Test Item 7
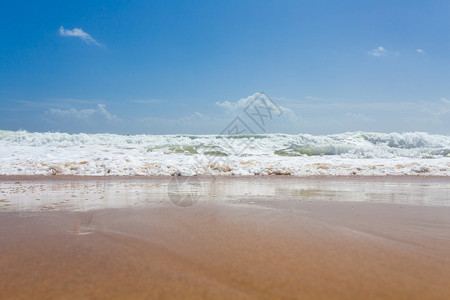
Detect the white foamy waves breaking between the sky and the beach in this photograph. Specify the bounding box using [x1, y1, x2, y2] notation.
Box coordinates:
[0, 131, 450, 176]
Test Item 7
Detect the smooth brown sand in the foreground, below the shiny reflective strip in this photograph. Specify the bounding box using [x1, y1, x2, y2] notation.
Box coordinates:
[0, 179, 450, 299]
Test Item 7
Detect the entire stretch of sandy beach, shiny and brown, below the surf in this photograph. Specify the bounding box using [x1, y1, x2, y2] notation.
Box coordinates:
[0, 177, 450, 299]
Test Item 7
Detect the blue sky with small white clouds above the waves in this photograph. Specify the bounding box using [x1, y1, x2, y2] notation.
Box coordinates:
[0, 0, 450, 135]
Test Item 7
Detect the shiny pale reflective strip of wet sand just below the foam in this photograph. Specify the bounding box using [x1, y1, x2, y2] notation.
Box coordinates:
[0, 177, 450, 212]
